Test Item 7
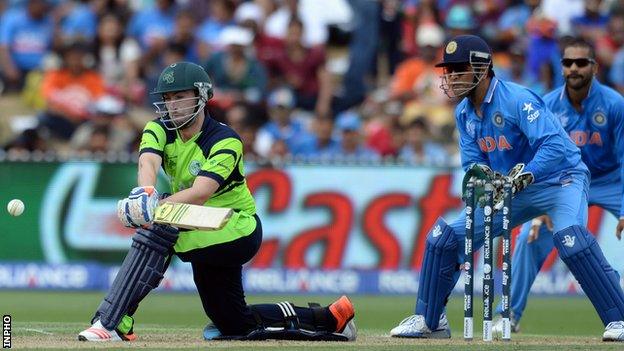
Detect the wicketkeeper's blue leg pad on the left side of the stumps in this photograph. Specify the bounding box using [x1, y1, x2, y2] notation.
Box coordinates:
[416, 218, 459, 330]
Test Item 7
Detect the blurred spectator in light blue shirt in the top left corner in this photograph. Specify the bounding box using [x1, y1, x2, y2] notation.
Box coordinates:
[0, 0, 54, 91]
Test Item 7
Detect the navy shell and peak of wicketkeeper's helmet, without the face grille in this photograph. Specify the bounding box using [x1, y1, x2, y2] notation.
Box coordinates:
[436, 35, 492, 67]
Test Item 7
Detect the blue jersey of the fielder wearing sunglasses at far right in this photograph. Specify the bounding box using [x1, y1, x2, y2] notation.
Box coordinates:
[544, 79, 624, 216]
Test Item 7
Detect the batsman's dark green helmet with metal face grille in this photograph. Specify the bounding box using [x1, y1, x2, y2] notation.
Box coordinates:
[152, 62, 213, 130]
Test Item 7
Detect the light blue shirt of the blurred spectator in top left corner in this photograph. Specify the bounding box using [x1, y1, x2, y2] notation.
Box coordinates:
[0, 7, 54, 71]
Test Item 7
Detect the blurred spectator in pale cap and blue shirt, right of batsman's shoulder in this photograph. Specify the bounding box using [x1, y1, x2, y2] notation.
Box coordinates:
[255, 88, 310, 157]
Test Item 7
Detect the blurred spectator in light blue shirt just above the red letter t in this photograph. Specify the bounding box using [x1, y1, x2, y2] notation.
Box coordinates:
[399, 117, 449, 166]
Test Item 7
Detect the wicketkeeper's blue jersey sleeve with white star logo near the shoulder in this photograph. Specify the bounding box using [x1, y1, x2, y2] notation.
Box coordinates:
[515, 93, 567, 182]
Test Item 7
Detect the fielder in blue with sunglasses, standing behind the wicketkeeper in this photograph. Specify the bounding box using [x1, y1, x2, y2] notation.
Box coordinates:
[494, 39, 624, 338]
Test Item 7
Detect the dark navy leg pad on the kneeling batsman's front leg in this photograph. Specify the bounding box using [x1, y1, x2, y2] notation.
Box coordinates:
[95, 225, 178, 330]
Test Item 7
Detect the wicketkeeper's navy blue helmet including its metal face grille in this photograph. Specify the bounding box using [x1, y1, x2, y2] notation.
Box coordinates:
[436, 35, 492, 97]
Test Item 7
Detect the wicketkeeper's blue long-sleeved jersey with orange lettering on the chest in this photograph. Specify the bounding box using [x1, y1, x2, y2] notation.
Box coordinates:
[455, 77, 587, 183]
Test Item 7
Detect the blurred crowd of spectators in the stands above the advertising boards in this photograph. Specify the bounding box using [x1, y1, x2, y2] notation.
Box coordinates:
[0, 0, 624, 166]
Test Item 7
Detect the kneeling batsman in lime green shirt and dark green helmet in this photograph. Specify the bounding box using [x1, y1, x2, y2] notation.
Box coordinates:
[78, 62, 356, 341]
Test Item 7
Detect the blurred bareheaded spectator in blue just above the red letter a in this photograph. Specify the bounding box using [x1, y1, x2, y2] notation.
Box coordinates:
[290, 116, 340, 159]
